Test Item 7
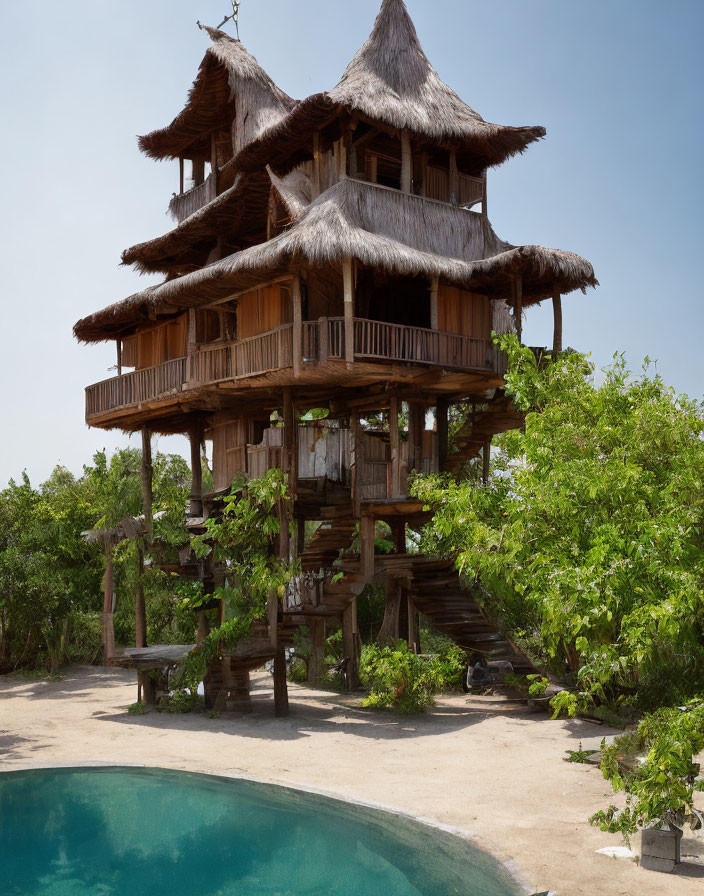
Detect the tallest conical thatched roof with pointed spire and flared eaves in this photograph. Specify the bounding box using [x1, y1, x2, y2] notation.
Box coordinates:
[231, 0, 545, 172]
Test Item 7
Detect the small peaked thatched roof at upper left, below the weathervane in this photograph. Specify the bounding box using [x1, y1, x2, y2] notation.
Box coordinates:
[139, 28, 295, 159]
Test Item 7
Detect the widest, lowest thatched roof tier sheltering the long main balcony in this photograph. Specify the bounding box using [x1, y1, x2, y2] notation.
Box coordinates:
[74, 179, 597, 342]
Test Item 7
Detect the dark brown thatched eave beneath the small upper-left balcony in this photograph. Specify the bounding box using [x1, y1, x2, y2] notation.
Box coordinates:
[122, 171, 271, 274]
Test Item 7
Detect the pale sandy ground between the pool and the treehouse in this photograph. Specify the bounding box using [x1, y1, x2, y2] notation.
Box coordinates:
[0, 668, 704, 896]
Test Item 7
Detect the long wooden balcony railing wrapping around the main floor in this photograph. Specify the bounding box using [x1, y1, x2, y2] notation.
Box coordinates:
[86, 317, 506, 421]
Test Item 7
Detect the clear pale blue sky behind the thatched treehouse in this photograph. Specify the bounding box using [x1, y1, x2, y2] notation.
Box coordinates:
[0, 0, 704, 485]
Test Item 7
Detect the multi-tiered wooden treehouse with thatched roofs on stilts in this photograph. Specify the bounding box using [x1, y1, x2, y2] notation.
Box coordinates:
[75, 0, 596, 712]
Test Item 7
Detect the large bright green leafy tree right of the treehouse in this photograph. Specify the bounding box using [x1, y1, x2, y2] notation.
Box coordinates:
[414, 336, 704, 713]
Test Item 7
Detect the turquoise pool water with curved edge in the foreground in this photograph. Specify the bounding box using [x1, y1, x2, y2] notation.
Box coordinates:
[0, 768, 518, 896]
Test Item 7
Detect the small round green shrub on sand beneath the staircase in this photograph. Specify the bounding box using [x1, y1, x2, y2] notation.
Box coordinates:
[360, 641, 441, 713]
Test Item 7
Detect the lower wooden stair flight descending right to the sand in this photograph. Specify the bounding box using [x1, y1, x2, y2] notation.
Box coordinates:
[410, 557, 535, 674]
